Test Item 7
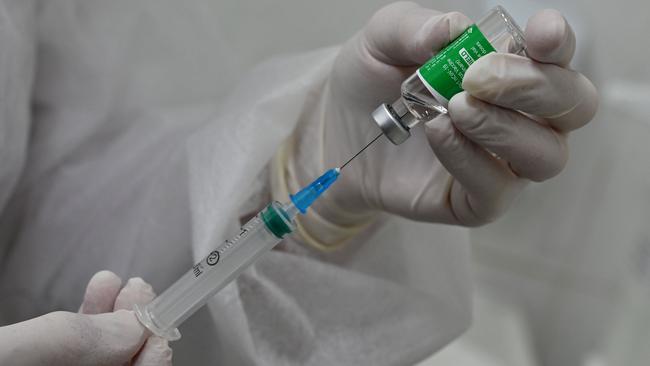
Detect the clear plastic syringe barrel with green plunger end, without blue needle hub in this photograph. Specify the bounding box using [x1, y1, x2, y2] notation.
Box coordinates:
[135, 202, 293, 340]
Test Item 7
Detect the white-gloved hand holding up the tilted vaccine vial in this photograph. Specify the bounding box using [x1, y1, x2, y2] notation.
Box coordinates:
[293, 2, 598, 226]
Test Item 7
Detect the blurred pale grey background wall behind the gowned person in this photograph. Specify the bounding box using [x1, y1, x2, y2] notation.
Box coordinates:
[176, 0, 650, 366]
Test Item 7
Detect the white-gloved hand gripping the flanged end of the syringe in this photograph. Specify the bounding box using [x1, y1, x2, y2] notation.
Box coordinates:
[0, 271, 172, 366]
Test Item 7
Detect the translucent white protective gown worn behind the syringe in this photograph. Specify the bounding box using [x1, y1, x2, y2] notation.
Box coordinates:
[0, 0, 471, 365]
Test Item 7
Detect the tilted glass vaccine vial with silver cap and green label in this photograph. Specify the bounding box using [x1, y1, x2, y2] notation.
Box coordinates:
[372, 6, 526, 145]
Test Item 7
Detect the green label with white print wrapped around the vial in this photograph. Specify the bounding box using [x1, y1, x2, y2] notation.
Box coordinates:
[418, 24, 496, 105]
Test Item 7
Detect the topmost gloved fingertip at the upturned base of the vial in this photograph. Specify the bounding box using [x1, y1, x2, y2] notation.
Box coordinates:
[525, 9, 575, 66]
